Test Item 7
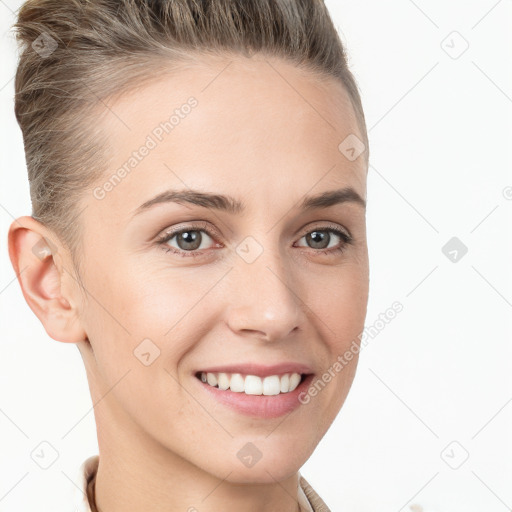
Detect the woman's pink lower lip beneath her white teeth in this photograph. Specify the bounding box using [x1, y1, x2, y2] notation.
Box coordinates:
[194, 374, 314, 418]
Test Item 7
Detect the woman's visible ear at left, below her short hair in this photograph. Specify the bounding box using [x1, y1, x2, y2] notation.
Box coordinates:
[8, 216, 87, 343]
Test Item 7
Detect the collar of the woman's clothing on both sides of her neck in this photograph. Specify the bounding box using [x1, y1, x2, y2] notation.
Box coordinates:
[73, 455, 330, 512]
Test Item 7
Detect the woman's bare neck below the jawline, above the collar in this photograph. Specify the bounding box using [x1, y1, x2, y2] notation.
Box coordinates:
[91, 400, 300, 512]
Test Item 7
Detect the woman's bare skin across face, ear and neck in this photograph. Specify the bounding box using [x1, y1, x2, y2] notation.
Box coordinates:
[9, 56, 369, 512]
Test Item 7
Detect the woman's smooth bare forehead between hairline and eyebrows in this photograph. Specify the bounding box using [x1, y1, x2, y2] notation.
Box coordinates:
[90, 56, 366, 220]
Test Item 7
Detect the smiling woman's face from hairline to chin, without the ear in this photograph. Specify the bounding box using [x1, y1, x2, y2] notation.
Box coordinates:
[74, 57, 369, 482]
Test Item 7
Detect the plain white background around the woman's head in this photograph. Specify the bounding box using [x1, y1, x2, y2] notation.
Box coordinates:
[0, 0, 512, 512]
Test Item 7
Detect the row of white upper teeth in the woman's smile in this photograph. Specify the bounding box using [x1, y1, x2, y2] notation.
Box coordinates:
[201, 372, 301, 396]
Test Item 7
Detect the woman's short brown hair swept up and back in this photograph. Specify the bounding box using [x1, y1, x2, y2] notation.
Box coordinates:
[15, 0, 368, 270]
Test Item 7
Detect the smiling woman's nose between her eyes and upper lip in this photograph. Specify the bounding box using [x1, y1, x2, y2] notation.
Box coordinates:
[227, 245, 304, 342]
